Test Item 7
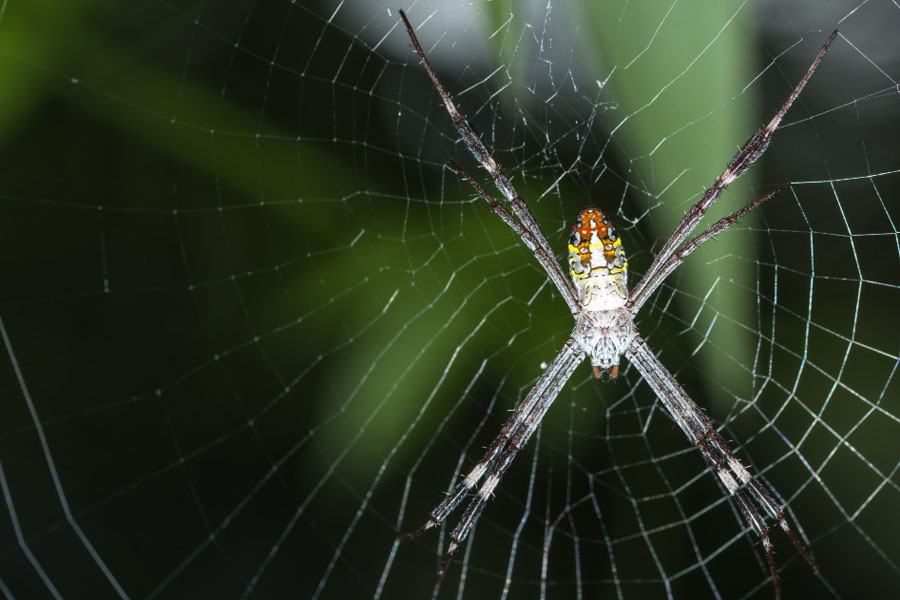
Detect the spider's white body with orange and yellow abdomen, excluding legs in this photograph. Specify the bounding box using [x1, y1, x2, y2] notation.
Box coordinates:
[569, 206, 635, 379]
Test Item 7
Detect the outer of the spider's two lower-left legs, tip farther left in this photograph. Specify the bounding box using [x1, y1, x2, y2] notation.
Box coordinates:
[400, 338, 584, 549]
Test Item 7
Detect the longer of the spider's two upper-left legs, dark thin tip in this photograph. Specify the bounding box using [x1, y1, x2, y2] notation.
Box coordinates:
[399, 10, 578, 314]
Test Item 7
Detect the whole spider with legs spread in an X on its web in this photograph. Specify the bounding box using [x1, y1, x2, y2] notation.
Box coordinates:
[400, 10, 838, 598]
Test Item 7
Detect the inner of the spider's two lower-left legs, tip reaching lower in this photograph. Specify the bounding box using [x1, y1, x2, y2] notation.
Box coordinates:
[437, 339, 584, 581]
